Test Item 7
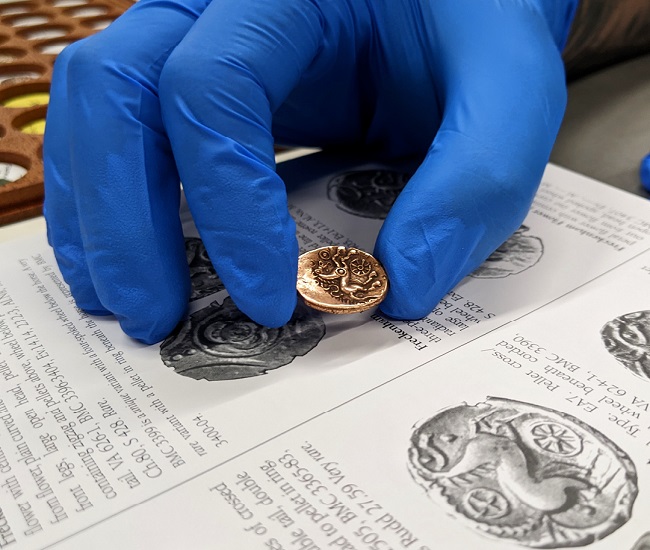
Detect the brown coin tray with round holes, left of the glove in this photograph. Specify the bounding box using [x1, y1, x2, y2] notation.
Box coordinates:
[0, 0, 133, 225]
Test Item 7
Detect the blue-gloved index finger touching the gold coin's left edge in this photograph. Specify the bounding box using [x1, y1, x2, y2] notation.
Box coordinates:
[160, 0, 344, 327]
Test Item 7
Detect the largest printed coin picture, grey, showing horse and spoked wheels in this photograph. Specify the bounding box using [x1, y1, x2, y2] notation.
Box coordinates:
[409, 397, 638, 548]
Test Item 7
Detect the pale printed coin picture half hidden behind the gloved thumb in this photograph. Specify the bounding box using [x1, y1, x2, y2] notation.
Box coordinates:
[470, 225, 544, 279]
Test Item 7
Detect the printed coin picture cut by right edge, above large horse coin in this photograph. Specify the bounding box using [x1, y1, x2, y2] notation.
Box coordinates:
[600, 311, 650, 380]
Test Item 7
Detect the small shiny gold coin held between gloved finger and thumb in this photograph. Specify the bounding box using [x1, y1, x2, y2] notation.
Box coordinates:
[297, 246, 388, 313]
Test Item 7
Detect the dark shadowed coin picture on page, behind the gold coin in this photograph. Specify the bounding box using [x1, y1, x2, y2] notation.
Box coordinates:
[327, 170, 411, 220]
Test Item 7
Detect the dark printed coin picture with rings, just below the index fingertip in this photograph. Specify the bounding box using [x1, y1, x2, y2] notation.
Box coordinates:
[160, 297, 325, 380]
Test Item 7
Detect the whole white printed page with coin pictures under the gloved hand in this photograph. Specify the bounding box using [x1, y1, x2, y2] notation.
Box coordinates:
[0, 154, 650, 550]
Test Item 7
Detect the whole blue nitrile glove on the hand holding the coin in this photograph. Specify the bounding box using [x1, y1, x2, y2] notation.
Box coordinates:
[44, 0, 577, 342]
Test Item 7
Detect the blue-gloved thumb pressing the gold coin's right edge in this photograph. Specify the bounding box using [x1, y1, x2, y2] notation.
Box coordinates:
[375, 0, 566, 319]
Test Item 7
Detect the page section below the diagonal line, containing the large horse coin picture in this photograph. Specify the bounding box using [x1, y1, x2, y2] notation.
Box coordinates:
[66, 253, 650, 550]
